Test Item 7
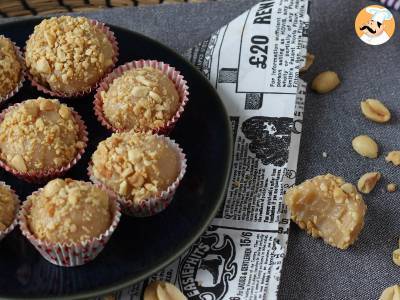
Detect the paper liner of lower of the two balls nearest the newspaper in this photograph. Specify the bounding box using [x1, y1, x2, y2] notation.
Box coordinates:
[88, 137, 187, 217]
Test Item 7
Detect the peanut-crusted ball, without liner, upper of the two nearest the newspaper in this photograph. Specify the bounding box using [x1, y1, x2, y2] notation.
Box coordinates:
[101, 67, 180, 132]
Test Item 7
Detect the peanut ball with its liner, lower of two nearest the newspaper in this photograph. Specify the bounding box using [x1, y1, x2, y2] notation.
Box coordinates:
[89, 131, 186, 216]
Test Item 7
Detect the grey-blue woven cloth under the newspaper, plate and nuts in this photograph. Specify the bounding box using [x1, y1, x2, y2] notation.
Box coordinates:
[0, 0, 400, 300]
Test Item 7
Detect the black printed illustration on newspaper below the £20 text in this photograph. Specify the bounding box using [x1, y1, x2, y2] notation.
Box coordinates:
[241, 117, 293, 167]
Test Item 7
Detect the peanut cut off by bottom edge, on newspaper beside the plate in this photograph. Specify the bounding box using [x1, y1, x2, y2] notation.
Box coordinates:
[143, 281, 187, 300]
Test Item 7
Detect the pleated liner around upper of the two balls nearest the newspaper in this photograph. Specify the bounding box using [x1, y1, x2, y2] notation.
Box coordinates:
[94, 60, 189, 134]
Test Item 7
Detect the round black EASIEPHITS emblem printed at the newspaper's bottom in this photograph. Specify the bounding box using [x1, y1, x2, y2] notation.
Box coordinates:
[178, 232, 237, 300]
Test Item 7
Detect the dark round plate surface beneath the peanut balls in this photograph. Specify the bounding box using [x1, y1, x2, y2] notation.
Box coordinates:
[0, 19, 232, 298]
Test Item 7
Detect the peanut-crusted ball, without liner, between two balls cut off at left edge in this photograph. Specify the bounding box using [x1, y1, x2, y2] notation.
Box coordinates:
[0, 98, 85, 173]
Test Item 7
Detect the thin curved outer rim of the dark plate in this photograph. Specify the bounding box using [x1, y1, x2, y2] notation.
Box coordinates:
[0, 15, 233, 300]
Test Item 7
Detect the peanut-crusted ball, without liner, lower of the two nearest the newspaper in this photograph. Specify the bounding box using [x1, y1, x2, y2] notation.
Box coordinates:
[92, 131, 180, 203]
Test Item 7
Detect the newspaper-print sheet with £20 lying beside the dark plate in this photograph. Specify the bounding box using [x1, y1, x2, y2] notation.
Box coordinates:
[108, 0, 309, 300]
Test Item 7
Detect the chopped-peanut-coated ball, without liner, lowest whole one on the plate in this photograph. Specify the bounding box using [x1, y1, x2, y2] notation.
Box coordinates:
[28, 179, 112, 243]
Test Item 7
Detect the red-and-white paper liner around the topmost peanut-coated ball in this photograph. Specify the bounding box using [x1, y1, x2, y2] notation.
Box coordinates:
[25, 19, 119, 98]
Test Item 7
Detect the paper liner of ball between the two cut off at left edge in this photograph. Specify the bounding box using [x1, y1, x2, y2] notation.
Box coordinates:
[0, 102, 89, 183]
